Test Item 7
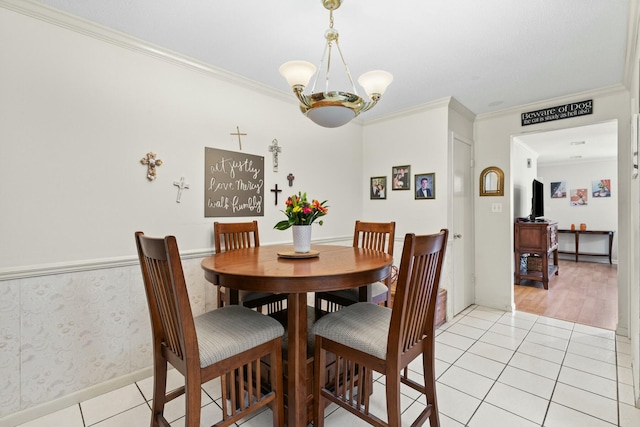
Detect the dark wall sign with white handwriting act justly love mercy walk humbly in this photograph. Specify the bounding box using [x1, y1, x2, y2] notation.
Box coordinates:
[204, 147, 264, 218]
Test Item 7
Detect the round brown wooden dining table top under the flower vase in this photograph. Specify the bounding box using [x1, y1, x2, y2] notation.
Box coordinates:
[201, 245, 393, 293]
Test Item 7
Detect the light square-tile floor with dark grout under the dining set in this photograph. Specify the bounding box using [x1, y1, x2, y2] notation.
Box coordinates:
[12, 306, 640, 427]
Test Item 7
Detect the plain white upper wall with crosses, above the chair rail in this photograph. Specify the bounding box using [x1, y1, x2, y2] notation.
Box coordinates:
[0, 5, 362, 268]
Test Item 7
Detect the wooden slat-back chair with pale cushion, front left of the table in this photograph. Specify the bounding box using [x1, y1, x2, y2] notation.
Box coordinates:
[135, 231, 284, 427]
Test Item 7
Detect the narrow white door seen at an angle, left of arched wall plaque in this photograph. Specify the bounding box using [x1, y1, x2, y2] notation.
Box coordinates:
[448, 134, 475, 316]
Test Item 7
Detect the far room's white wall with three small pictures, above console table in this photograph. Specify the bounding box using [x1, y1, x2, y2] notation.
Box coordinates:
[538, 160, 618, 263]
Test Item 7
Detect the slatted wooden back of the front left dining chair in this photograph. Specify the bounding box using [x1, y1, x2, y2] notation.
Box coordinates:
[136, 231, 198, 361]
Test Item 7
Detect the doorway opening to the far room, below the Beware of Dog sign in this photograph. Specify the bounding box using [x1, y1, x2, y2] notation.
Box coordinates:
[511, 120, 618, 330]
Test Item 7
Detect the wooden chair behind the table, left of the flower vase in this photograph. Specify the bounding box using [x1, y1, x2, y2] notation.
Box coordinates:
[213, 221, 287, 314]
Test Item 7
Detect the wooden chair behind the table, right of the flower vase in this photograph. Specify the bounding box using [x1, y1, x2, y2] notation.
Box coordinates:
[315, 221, 396, 312]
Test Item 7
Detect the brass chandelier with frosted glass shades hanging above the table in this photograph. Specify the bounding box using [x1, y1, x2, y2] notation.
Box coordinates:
[280, 0, 393, 128]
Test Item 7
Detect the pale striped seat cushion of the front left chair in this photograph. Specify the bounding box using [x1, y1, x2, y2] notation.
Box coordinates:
[194, 305, 284, 368]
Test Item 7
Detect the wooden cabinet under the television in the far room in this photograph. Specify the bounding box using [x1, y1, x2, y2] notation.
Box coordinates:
[514, 221, 558, 289]
